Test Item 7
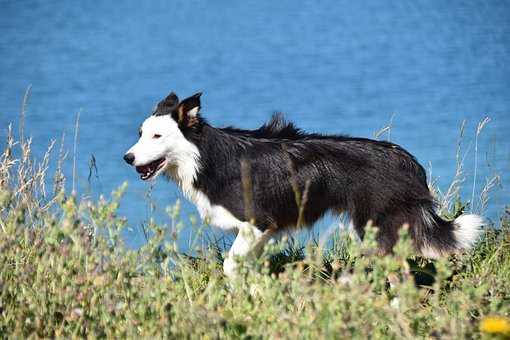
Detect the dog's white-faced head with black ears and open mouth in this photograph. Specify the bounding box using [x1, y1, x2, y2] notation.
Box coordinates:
[124, 92, 201, 180]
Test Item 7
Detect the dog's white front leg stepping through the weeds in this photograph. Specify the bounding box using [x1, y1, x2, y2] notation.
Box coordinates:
[223, 222, 272, 279]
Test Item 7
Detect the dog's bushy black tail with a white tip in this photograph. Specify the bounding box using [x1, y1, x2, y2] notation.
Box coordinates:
[414, 209, 487, 258]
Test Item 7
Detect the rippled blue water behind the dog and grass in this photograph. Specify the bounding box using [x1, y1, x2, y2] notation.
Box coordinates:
[0, 0, 510, 247]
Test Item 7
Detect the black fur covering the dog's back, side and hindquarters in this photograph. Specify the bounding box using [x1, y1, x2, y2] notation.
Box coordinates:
[178, 114, 456, 253]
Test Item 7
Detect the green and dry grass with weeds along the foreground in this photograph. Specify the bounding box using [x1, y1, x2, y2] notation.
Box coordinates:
[0, 116, 510, 339]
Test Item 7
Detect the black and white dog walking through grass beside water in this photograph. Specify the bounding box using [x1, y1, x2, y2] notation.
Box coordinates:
[124, 93, 484, 276]
